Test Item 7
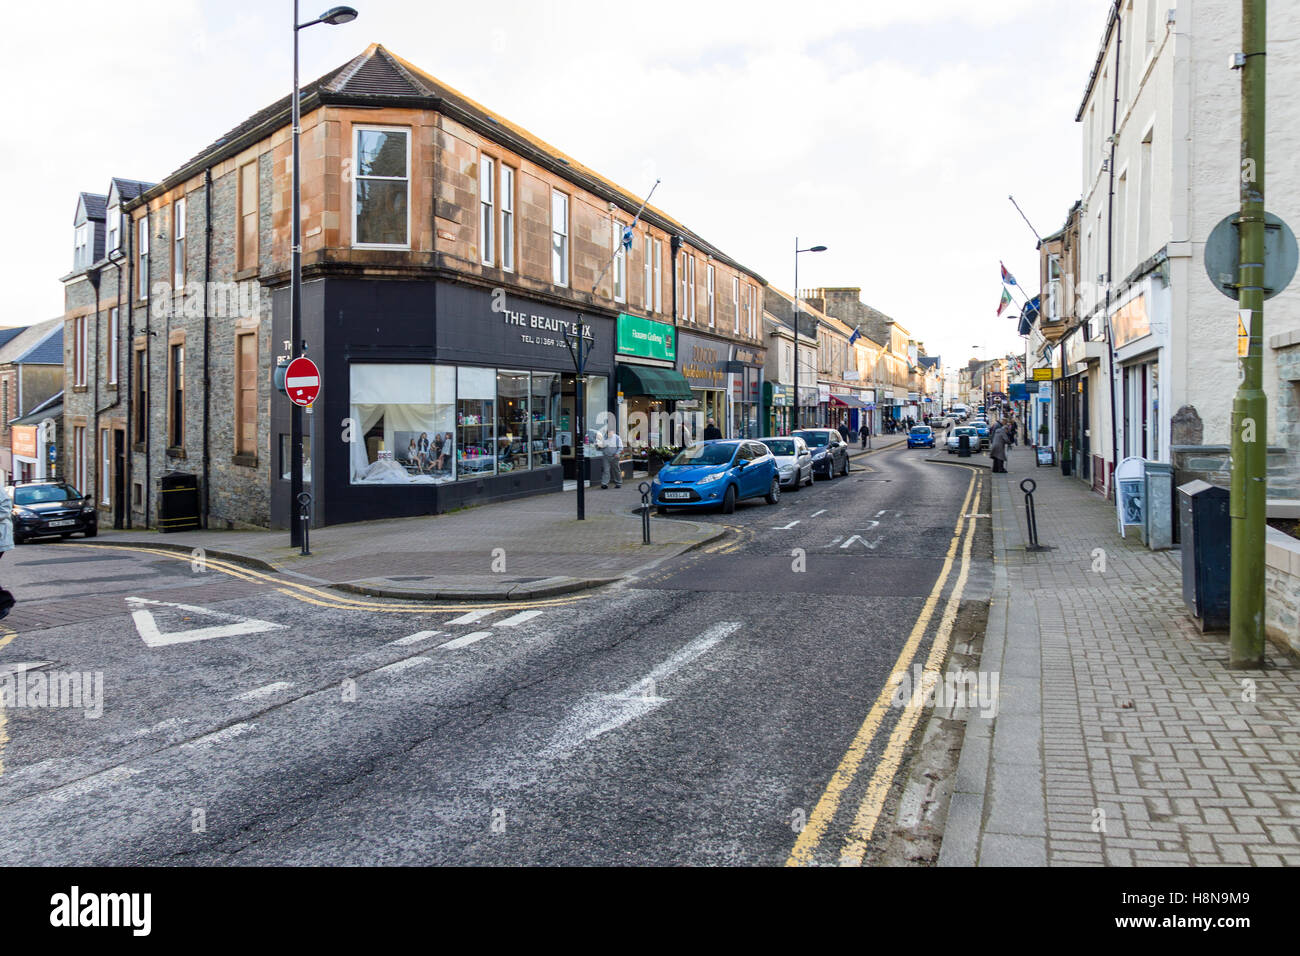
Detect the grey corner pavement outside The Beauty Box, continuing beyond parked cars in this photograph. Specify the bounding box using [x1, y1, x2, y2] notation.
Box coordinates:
[96, 434, 906, 601]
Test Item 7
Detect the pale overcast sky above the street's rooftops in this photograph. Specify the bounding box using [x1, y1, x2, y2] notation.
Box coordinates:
[0, 0, 1109, 364]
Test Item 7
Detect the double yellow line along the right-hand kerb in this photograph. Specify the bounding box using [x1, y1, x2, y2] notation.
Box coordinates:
[785, 470, 984, 866]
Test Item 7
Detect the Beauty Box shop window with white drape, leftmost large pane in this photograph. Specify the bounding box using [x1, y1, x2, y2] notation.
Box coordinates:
[350, 363, 456, 484]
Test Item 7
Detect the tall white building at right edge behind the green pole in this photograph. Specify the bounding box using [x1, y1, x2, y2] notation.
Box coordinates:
[1076, 0, 1300, 489]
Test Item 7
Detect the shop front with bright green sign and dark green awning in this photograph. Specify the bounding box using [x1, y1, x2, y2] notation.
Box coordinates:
[614, 313, 694, 450]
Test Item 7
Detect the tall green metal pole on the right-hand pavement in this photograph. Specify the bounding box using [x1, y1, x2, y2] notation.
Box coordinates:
[1229, 0, 1269, 669]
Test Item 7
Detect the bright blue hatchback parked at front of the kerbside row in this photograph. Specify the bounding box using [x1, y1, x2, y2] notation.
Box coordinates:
[650, 440, 781, 515]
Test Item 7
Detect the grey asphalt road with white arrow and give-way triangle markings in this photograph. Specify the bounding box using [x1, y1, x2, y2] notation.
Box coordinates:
[0, 449, 991, 865]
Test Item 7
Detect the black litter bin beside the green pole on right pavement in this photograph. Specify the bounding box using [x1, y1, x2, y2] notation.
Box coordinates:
[1178, 480, 1232, 631]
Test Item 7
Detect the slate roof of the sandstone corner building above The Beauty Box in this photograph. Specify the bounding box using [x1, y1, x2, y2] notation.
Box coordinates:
[134, 43, 766, 285]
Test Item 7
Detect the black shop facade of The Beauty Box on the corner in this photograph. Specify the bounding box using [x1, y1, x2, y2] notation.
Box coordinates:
[270, 278, 615, 528]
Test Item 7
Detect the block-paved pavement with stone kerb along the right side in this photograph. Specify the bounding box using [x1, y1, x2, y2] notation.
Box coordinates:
[939, 446, 1300, 866]
